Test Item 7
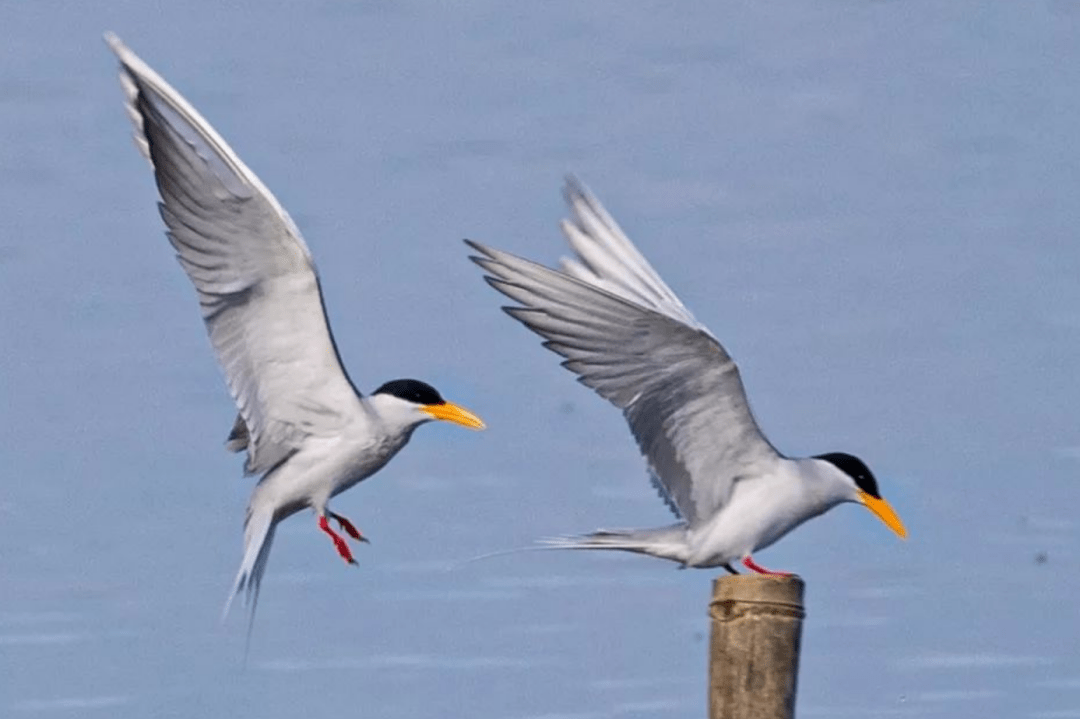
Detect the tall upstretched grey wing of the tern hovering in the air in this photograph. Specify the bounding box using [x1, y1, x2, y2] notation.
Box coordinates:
[106, 35, 362, 474]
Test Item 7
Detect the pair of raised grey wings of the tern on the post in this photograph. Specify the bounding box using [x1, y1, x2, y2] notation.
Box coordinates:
[469, 186, 780, 525]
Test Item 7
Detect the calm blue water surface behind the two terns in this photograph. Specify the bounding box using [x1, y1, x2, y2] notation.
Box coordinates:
[0, 0, 1080, 719]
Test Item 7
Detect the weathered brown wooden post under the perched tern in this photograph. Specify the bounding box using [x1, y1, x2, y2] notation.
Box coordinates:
[708, 574, 806, 719]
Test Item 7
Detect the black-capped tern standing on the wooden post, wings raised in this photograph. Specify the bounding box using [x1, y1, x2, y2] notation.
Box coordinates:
[465, 177, 907, 574]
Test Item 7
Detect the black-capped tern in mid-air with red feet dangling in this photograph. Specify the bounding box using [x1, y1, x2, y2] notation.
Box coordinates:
[105, 33, 484, 622]
